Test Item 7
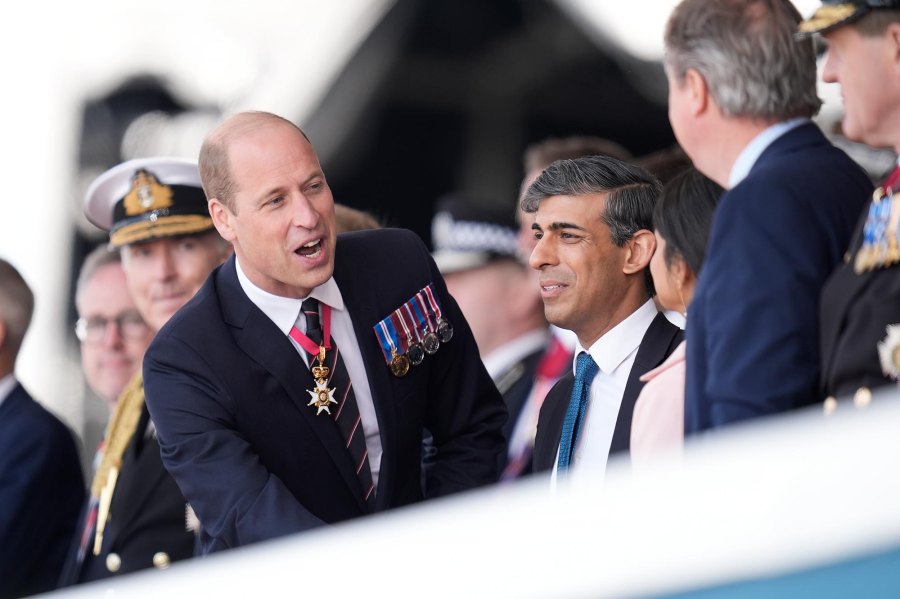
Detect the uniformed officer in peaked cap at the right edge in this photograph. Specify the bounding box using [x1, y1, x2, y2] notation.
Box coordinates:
[798, 0, 900, 413]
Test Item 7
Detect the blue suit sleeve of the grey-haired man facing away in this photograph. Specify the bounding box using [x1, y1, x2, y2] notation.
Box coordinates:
[688, 182, 833, 427]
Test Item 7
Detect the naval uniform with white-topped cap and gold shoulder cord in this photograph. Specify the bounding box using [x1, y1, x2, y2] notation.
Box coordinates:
[60, 157, 215, 586]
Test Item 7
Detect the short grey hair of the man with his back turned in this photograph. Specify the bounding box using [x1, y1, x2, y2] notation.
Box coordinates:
[665, 0, 822, 121]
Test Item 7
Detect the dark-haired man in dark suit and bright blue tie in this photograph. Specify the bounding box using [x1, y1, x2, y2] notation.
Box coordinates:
[522, 156, 682, 484]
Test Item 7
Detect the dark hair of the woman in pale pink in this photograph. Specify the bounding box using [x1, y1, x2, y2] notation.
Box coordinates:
[653, 167, 725, 274]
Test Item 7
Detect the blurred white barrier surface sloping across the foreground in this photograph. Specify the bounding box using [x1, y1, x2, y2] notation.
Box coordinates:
[47, 394, 900, 598]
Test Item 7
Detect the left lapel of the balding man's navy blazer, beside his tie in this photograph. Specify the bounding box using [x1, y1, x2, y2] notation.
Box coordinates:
[218, 257, 367, 511]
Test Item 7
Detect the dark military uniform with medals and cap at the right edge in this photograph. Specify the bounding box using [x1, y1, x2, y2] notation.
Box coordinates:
[797, 0, 900, 404]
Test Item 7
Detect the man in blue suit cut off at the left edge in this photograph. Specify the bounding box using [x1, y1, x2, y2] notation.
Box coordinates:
[0, 260, 85, 598]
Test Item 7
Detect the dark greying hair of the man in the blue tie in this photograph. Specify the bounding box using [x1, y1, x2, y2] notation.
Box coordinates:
[522, 156, 662, 296]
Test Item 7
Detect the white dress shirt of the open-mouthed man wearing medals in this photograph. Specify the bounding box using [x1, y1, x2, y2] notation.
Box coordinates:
[235, 258, 381, 489]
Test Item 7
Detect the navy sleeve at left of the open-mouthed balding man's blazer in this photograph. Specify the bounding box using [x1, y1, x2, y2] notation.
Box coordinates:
[144, 335, 323, 553]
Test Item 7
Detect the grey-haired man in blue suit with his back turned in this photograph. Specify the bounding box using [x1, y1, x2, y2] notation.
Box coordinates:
[665, 0, 871, 434]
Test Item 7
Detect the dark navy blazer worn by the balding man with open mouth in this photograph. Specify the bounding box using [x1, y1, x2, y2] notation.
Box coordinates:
[144, 229, 506, 551]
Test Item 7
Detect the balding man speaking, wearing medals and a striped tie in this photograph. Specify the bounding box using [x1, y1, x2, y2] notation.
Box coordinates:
[144, 113, 506, 552]
